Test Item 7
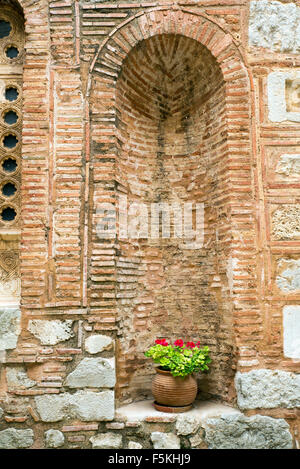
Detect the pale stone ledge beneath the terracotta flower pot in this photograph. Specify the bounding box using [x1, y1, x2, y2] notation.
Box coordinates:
[116, 400, 242, 423]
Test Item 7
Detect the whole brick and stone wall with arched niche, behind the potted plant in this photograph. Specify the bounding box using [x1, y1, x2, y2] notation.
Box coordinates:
[0, 0, 300, 449]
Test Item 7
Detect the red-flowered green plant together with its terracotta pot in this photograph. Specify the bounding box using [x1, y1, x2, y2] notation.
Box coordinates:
[145, 339, 211, 412]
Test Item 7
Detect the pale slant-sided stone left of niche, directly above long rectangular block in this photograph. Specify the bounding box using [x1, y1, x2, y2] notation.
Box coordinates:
[65, 358, 116, 388]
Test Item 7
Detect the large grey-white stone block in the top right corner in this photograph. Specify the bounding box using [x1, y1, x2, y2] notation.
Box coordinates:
[249, 0, 300, 53]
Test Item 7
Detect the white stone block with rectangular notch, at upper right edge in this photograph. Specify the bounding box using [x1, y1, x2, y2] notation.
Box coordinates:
[268, 71, 300, 122]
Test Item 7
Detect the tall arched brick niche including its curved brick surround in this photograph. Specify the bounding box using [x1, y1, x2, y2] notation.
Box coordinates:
[89, 5, 255, 401]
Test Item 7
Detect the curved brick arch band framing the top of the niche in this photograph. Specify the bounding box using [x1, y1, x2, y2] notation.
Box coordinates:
[87, 6, 251, 94]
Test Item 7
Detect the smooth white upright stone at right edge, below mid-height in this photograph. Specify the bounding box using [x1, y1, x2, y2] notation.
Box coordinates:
[283, 305, 300, 359]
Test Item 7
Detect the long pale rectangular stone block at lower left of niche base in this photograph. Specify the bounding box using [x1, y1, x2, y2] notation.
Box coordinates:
[35, 391, 114, 422]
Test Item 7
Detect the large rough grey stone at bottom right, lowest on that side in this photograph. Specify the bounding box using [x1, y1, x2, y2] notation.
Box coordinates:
[205, 415, 292, 449]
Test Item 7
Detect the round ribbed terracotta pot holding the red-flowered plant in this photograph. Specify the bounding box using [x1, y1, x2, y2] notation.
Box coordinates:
[152, 368, 197, 412]
